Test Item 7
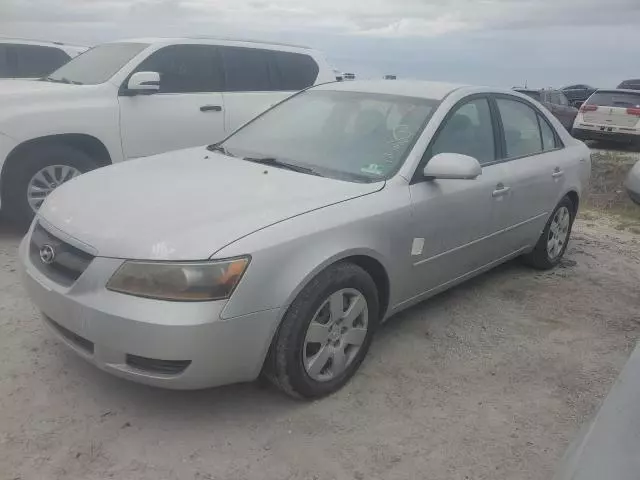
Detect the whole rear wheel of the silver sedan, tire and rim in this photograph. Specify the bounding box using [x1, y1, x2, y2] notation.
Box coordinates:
[523, 197, 575, 270]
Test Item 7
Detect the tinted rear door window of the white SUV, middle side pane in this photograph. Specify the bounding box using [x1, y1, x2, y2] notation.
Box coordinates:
[220, 47, 276, 92]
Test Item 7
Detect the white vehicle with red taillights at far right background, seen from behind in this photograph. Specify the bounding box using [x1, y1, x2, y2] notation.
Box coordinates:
[571, 89, 640, 145]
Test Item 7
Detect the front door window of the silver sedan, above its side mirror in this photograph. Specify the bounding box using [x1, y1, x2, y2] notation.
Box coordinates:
[429, 98, 496, 165]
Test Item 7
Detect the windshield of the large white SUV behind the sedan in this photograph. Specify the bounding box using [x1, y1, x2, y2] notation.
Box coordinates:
[47, 43, 149, 85]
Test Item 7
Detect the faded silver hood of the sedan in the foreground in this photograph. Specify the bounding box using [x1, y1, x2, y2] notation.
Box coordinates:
[39, 147, 384, 260]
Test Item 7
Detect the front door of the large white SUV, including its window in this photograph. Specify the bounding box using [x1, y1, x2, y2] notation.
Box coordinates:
[118, 44, 224, 158]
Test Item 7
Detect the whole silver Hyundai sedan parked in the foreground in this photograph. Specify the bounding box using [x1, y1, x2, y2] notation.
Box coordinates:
[20, 81, 591, 398]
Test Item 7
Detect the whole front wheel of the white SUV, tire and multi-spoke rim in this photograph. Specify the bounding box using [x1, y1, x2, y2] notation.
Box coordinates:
[3, 145, 97, 224]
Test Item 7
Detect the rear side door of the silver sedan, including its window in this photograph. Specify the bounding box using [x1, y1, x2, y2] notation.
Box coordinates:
[495, 95, 566, 252]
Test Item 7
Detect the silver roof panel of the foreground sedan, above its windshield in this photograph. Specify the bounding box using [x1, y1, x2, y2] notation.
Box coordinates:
[313, 80, 470, 100]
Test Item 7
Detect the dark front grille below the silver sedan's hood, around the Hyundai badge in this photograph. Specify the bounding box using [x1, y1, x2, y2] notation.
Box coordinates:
[29, 223, 95, 286]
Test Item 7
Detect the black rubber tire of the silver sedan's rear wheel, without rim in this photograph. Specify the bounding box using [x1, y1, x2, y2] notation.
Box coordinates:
[523, 197, 576, 270]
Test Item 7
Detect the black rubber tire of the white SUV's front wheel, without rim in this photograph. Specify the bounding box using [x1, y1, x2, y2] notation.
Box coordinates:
[2, 145, 98, 225]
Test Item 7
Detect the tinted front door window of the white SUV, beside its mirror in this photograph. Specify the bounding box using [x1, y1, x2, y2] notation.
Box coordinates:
[135, 45, 222, 93]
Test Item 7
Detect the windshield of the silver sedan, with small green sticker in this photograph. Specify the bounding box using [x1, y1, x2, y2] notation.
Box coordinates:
[221, 90, 439, 182]
